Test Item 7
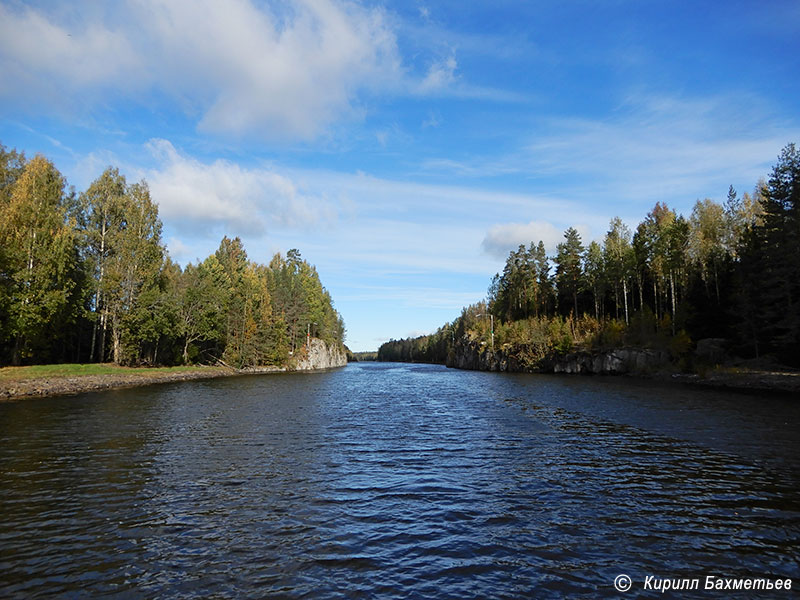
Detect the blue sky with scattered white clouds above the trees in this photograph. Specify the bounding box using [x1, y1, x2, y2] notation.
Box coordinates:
[0, 0, 800, 351]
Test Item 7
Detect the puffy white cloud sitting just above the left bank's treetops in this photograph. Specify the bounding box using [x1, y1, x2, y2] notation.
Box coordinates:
[142, 139, 336, 234]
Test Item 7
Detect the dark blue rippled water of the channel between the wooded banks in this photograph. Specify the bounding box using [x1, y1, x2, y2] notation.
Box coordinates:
[0, 363, 800, 598]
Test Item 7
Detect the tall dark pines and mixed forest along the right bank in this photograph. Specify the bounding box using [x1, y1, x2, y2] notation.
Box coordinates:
[378, 144, 800, 368]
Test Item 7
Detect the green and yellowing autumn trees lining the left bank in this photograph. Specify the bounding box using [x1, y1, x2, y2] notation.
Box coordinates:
[0, 145, 345, 368]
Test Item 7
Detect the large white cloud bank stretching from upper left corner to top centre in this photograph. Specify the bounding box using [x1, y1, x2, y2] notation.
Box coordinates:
[0, 0, 403, 139]
